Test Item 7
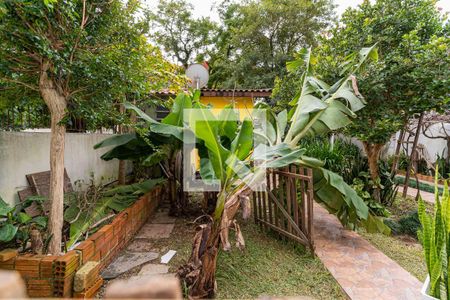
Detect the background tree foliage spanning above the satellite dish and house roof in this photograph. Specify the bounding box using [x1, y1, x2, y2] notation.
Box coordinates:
[148, 0, 333, 88]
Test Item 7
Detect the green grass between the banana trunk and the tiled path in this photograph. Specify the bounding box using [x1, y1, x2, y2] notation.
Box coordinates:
[217, 222, 346, 299]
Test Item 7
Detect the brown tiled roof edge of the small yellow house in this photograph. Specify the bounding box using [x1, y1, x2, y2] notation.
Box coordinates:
[152, 88, 272, 98]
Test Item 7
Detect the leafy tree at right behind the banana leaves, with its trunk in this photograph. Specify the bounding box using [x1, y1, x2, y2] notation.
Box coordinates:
[310, 0, 449, 200]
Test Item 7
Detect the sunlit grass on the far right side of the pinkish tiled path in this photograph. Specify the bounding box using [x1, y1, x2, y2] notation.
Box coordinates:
[359, 196, 432, 281]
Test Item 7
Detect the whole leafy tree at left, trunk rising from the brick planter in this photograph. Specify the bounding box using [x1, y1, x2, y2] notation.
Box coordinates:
[0, 0, 181, 254]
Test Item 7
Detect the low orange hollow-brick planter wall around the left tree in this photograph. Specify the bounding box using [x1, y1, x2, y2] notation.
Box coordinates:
[0, 187, 162, 298]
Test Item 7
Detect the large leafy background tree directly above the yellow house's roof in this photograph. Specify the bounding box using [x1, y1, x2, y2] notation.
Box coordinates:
[207, 0, 333, 88]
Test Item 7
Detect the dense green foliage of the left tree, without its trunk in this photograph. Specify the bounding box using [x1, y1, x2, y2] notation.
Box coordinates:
[0, 1, 181, 130]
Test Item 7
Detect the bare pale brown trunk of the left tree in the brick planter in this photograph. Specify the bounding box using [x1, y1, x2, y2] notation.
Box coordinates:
[39, 62, 67, 255]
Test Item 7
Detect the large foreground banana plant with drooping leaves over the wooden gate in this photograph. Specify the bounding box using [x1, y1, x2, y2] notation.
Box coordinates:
[98, 47, 386, 297]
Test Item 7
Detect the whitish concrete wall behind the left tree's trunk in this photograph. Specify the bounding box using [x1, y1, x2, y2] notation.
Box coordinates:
[0, 132, 130, 204]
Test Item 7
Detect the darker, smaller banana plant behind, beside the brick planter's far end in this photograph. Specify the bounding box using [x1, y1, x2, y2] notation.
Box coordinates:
[94, 91, 200, 214]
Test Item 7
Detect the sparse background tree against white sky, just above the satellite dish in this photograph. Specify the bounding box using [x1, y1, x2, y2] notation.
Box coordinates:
[147, 0, 216, 68]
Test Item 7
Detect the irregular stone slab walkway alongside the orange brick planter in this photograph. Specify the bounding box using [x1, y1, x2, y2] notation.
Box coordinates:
[101, 207, 176, 292]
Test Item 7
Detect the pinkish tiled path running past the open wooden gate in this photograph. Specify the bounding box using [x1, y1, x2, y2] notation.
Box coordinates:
[314, 204, 422, 300]
